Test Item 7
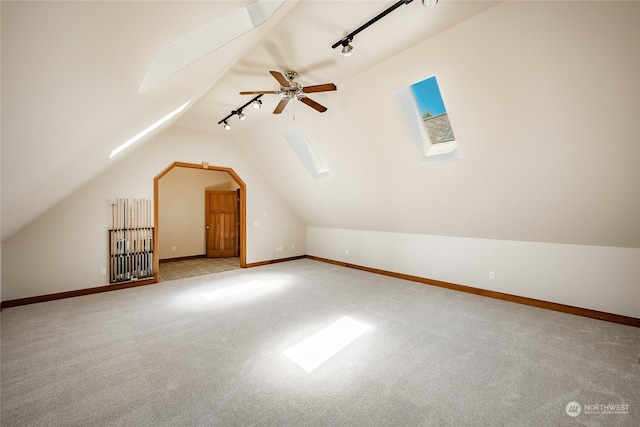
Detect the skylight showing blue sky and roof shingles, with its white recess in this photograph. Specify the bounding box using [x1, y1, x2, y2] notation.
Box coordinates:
[395, 77, 460, 163]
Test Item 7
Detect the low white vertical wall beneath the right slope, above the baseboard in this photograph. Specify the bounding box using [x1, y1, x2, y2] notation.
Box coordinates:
[307, 227, 640, 318]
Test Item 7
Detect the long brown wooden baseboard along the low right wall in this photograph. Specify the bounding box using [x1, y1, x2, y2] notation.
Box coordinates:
[306, 255, 640, 328]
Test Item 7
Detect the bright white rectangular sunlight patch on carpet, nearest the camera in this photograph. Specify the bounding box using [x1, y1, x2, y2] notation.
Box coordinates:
[282, 316, 371, 372]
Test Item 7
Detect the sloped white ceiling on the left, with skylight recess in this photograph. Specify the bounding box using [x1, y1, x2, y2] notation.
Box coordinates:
[1, 1, 293, 240]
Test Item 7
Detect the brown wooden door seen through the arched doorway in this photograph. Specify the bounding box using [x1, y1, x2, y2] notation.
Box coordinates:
[205, 191, 240, 258]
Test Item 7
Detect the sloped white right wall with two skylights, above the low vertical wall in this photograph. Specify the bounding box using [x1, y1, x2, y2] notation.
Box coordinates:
[241, 1, 640, 248]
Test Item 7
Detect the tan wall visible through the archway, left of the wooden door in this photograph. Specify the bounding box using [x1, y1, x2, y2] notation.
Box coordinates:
[158, 167, 238, 260]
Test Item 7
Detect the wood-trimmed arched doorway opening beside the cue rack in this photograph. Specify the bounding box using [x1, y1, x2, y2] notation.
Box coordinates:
[154, 162, 246, 282]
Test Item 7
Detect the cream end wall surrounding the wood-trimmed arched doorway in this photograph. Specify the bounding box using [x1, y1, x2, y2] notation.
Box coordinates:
[2, 127, 305, 301]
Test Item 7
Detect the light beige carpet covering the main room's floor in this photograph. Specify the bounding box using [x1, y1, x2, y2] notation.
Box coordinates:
[1, 259, 640, 427]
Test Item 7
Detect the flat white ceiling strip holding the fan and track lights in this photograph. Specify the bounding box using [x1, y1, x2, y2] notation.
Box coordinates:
[178, 0, 497, 137]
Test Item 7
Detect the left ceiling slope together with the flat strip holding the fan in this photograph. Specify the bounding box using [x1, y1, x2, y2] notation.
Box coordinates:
[1, 0, 497, 240]
